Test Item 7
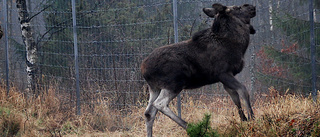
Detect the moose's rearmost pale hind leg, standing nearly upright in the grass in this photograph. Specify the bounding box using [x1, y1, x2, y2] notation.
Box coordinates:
[144, 88, 160, 137]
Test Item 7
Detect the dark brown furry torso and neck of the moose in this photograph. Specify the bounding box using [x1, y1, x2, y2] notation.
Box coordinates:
[141, 5, 252, 90]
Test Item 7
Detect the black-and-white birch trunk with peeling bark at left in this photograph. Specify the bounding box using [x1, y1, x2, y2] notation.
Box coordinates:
[16, 0, 39, 96]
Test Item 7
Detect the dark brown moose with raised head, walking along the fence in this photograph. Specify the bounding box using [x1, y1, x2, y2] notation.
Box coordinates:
[141, 3, 256, 137]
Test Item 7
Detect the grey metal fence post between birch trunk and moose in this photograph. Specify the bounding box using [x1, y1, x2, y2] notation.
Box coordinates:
[71, 0, 81, 115]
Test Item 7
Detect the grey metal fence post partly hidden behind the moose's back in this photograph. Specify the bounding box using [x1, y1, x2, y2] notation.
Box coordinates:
[172, 0, 181, 117]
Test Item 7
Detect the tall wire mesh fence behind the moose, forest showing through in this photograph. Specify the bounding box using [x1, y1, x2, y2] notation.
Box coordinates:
[0, 0, 320, 128]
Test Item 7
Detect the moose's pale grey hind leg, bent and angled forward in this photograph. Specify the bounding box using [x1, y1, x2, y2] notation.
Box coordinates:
[153, 89, 187, 129]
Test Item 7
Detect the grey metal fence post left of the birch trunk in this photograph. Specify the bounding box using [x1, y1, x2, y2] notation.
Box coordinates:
[2, 0, 10, 96]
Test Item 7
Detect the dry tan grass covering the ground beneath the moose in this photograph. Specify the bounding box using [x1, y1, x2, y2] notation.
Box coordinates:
[0, 88, 320, 137]
